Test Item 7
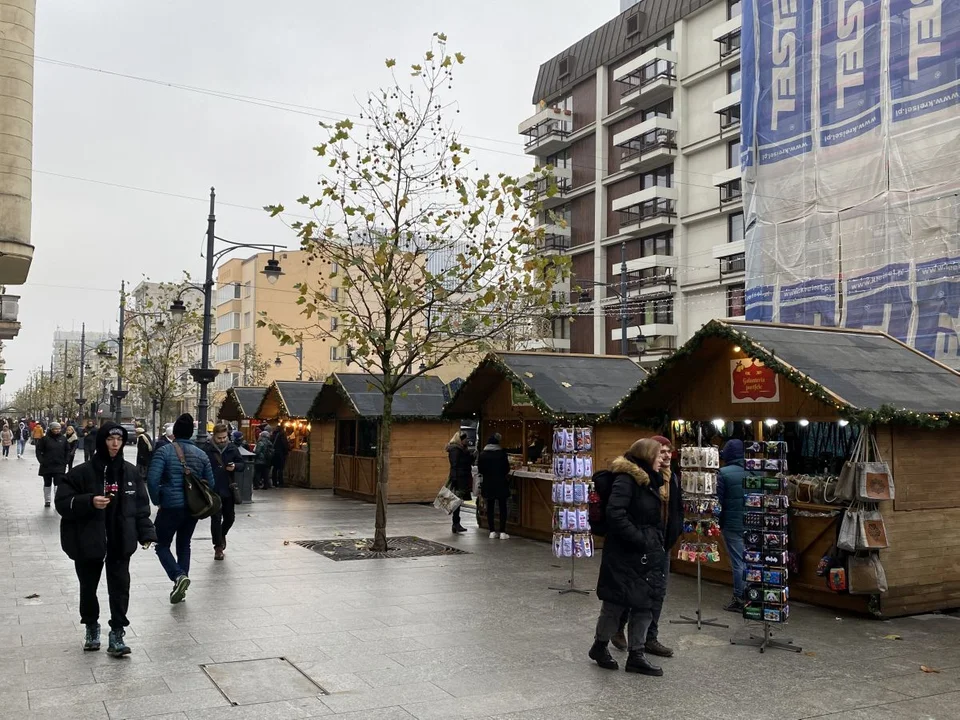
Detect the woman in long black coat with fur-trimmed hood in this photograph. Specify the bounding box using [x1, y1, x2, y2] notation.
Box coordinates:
[589, 438, 666, 677]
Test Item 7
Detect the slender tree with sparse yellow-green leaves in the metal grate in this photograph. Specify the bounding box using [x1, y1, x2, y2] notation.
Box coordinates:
[259, 33, 569, 551]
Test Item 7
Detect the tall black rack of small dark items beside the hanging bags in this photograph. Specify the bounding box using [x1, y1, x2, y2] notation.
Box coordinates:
[730, 441, 802, 652]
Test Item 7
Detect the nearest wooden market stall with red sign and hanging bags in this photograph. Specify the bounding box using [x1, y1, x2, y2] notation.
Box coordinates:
[612, 320, 960, 617]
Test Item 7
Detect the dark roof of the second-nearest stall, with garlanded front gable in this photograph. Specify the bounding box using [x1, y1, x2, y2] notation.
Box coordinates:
[445, 353, 644, 418]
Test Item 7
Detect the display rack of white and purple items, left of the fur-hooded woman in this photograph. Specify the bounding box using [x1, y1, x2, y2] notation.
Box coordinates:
[550, 427, 593, 595]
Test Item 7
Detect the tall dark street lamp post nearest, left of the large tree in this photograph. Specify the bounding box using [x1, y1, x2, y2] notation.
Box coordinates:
[170, 188, 283, 443]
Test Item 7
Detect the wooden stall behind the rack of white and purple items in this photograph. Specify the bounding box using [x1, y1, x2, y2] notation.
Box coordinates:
[445, 353, 656, 540]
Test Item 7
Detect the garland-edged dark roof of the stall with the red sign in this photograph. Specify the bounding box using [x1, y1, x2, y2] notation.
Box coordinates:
[612, 320, 960, 423]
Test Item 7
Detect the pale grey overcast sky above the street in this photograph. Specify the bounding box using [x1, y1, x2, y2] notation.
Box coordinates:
[3, 0, 619, 398]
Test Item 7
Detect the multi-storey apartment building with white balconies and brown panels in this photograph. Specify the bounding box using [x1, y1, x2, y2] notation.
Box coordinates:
[519, 0, 745, 363]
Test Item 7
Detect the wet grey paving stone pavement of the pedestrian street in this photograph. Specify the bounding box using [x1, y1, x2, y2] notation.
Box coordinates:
[0, 452, 960, 720]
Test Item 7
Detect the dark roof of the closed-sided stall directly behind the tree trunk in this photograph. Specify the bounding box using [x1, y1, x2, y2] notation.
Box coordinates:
[309, 373, 454, 420]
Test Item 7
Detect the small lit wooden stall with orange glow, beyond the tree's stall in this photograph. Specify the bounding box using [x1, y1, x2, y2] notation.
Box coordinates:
[256, 380, 329, 487]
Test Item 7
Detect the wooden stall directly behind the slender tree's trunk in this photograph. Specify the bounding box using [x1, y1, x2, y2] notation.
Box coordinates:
[309, 373, 459, 503]
